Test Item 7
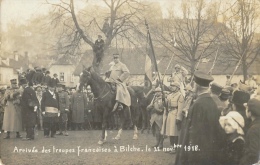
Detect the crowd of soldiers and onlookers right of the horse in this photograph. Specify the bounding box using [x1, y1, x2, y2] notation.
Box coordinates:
[147, 65, 260, 165]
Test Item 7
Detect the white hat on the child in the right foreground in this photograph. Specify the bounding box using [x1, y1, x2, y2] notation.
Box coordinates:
[219, 111, 245, 135]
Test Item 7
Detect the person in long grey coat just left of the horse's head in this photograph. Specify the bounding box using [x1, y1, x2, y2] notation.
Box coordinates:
[71, 90, 87, 129]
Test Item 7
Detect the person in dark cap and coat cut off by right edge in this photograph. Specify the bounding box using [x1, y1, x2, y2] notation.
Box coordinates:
[239, 99, 260, 165]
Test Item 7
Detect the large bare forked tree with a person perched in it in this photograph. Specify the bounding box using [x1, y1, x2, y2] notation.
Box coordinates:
[46, 0, 146, 72]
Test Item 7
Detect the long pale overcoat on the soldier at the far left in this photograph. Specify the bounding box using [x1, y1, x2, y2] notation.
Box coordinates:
[3, 89, 23, 132]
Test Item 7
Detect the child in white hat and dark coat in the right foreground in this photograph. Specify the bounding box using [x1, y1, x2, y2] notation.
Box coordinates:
[219, 111, 245, 165]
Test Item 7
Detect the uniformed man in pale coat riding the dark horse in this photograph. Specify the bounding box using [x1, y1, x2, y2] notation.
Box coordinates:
[106, 53, 131, 112]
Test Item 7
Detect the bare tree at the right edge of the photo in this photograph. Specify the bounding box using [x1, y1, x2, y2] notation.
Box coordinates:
[220, 0, 260, 81]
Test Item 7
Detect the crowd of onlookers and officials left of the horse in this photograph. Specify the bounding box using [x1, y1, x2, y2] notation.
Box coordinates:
[0, 68, 105, 140]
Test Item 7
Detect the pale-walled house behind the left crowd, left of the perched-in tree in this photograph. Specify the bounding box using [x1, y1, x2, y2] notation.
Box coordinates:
[49, 55, 78, 87]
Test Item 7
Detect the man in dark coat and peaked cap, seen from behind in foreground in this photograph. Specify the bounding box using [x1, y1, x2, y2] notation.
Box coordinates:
[175, 71, 224, 165]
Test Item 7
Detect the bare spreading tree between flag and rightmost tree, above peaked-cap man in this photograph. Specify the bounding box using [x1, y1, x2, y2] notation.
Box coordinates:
[153, 0, 220, 74]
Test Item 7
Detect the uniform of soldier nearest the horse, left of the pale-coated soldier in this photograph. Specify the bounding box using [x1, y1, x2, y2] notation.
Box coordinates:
[147, 89, 164, 148]
